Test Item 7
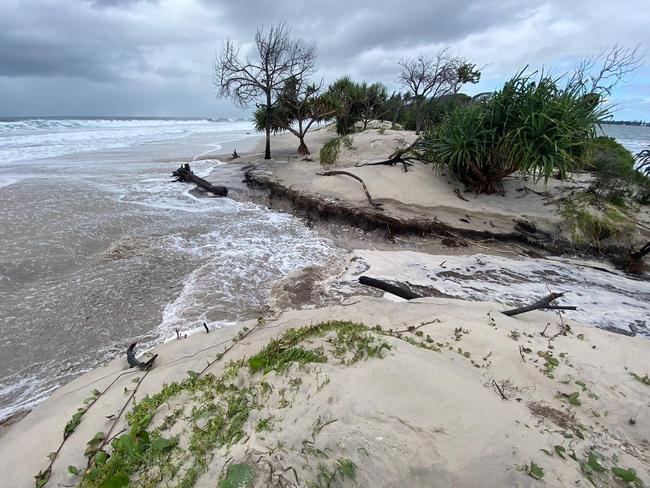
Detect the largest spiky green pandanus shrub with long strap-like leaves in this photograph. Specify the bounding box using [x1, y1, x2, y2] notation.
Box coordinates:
[425, 73, 607, 193]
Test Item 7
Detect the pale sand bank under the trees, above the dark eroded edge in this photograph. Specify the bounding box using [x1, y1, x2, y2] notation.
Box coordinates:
[242, 127, 650, 252]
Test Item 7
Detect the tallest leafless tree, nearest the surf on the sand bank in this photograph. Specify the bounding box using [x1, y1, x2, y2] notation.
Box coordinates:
[214, 22, 316, 159]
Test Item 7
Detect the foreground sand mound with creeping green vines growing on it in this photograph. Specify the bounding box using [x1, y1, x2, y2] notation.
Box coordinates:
[0, 297, 650, 487]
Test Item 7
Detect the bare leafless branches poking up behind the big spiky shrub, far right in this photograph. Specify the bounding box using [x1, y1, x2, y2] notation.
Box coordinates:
[568, 44, 645, 97]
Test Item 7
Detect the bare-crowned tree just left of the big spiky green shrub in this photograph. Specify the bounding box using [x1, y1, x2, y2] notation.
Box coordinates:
[399, 47, 481, 135]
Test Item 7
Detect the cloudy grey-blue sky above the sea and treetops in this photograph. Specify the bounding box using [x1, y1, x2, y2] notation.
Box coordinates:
[0, 0, 650, 120]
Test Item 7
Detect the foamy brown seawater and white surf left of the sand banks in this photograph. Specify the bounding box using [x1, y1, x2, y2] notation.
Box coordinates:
[0, 118, 342, 419]
